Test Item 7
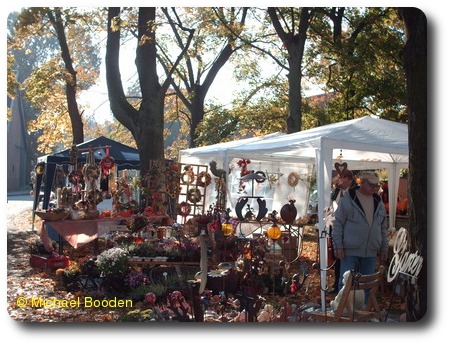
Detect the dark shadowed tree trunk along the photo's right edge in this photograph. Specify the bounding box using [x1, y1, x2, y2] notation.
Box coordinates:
[399, 8, 428, 321]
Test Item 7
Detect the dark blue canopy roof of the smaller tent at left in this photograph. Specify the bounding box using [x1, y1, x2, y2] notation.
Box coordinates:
[38, 136, 140, 169]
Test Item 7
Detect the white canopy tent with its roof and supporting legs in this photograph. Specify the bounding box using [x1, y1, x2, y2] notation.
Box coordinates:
[180, 116, 409, 308]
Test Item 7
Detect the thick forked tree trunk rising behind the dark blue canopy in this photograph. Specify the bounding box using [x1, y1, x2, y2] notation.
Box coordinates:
[105, 7, 169, 175]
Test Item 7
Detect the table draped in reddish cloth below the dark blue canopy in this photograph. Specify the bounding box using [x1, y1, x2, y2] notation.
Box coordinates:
[40, 216, 172, 254]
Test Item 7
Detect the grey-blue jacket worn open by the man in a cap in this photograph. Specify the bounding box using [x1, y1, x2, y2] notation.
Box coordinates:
[332, 189, 388, 257]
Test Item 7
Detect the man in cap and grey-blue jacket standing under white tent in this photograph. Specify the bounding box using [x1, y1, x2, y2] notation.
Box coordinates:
[332, 171, 388, 289]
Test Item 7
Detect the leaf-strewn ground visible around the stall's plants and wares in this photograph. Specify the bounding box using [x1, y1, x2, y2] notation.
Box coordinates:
[7, 207, 400, 322]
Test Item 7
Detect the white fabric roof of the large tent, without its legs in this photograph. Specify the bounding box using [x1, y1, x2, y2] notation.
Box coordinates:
[180, 116, 408, 169]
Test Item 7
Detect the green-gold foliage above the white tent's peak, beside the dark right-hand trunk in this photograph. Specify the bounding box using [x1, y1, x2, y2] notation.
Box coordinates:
[304, 8, 406, 121]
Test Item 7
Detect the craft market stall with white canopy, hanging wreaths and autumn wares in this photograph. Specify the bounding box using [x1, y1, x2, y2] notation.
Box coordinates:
[28, 117, 408, 316]
